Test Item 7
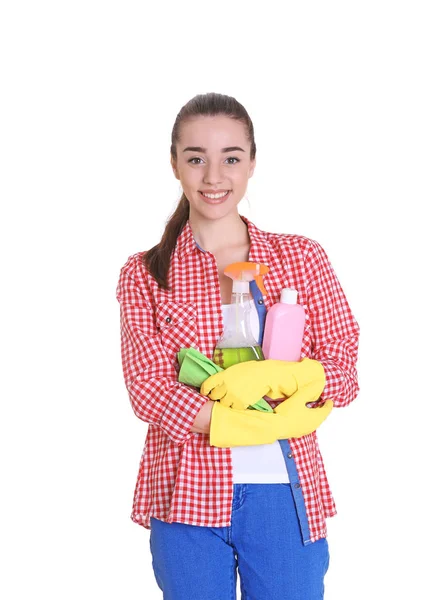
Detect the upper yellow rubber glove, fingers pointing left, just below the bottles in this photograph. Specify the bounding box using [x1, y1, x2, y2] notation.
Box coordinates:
[201, 358, 325, 410]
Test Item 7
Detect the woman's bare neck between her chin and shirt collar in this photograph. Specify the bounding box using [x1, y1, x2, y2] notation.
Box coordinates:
[189, 214, 249, 254]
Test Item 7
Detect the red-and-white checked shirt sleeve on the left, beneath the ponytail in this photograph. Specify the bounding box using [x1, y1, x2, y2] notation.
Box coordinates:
[116, 257, 208, 445]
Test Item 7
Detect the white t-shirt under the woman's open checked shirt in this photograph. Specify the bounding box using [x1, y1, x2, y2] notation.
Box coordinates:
[222, 300, 289, 483]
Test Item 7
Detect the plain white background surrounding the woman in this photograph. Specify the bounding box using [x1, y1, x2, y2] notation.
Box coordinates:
[0, 0, 435, 600]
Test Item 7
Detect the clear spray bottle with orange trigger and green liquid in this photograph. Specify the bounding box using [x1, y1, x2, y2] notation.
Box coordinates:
[213, 262, 269, 369]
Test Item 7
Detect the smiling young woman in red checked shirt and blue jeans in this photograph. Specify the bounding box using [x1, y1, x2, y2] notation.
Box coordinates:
[117, 94, 359, 600]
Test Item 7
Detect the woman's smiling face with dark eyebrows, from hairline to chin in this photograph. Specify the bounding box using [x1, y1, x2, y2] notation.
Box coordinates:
[171, 115, 255, 219]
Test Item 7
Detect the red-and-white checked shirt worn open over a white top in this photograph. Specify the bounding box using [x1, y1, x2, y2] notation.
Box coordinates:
[117, 217, 359, 542]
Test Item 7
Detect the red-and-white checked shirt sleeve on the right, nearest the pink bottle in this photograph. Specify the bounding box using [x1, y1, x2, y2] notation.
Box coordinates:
[305, 240, 359, 407]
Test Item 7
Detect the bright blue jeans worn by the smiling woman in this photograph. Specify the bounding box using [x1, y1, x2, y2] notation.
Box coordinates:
[150, 483, 329, 600]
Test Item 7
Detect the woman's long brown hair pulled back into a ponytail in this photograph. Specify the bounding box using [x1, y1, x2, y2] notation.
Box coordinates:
[142, 93, 256, 290]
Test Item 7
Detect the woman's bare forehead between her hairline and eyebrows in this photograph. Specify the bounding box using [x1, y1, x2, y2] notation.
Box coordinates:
[179, 115, 249, 150]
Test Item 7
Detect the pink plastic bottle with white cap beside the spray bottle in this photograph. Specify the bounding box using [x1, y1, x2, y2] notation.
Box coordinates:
[262, 288, 305, 361]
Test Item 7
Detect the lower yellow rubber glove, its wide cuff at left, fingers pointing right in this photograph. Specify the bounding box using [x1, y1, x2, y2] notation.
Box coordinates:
[210, 392, 332, 448]
